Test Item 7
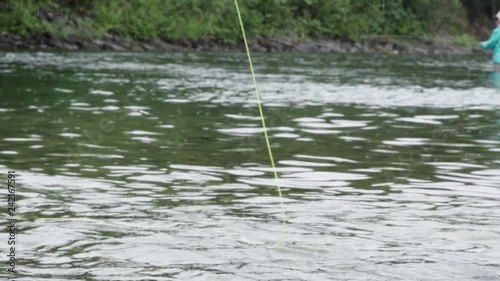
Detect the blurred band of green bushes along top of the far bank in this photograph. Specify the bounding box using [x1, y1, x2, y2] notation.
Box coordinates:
[0, 0, 500, 41]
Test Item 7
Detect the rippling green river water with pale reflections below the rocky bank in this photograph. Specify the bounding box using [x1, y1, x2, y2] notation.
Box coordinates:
[0, 52, 500, 281]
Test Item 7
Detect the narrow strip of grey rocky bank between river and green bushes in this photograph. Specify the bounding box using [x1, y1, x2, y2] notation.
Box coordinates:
[0, 32, 485, 55]
